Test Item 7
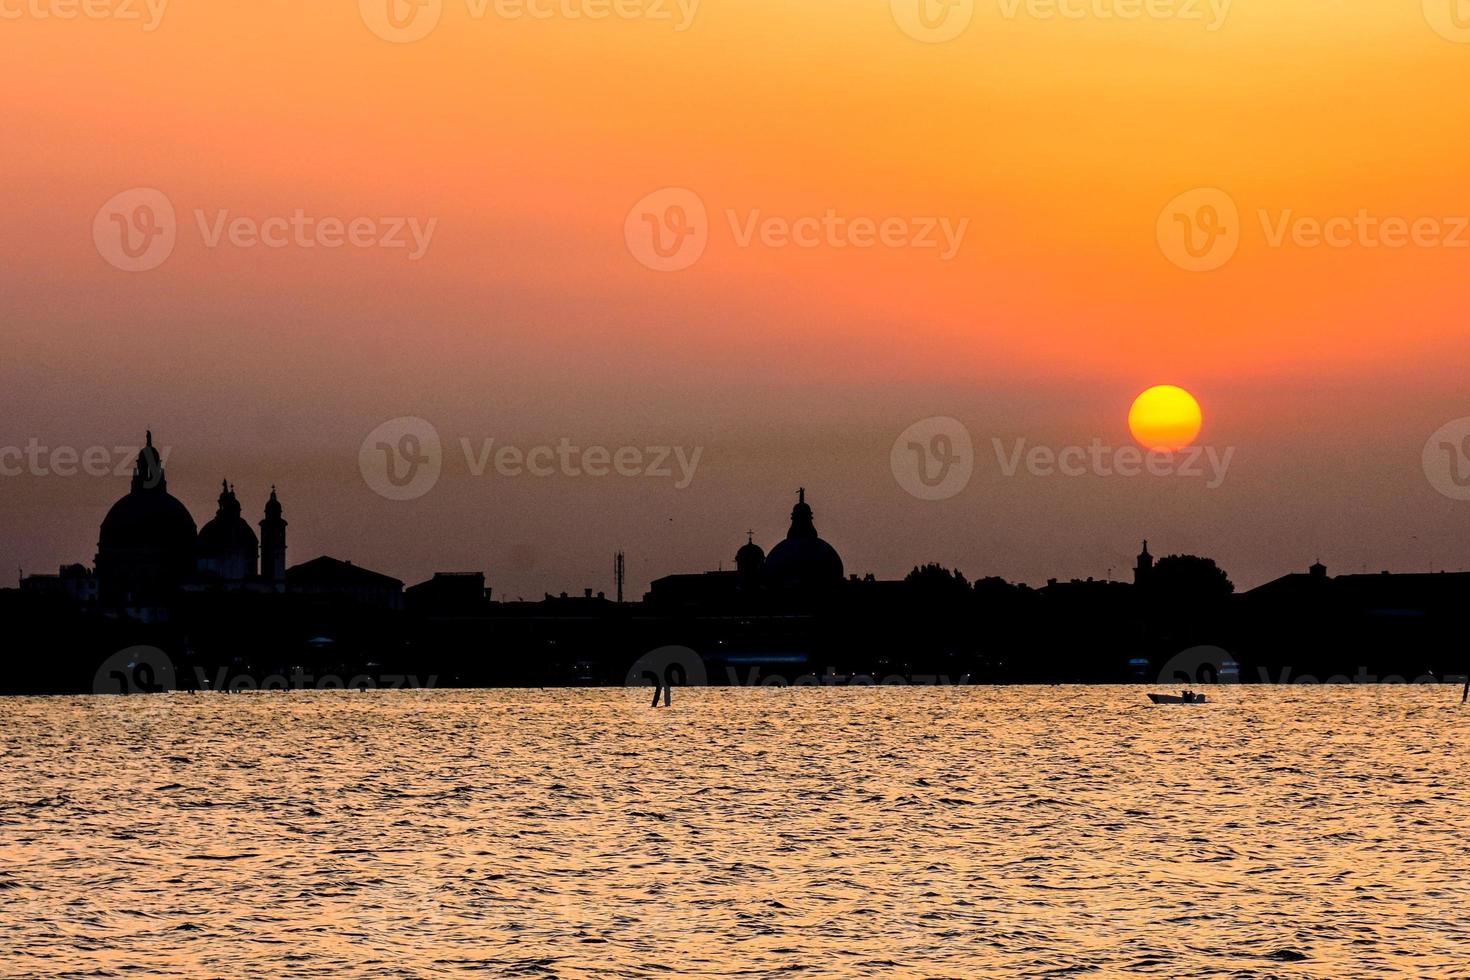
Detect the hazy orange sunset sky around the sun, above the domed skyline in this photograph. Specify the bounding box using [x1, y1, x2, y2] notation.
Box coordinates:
[0, 0, 1470, 598]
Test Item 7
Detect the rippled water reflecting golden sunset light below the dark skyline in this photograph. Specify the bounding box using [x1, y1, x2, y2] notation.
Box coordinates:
[0, 686, 1470, 977]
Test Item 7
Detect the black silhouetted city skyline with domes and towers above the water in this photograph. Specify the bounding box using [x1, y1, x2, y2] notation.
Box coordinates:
[0, 432, 1470, 691]
